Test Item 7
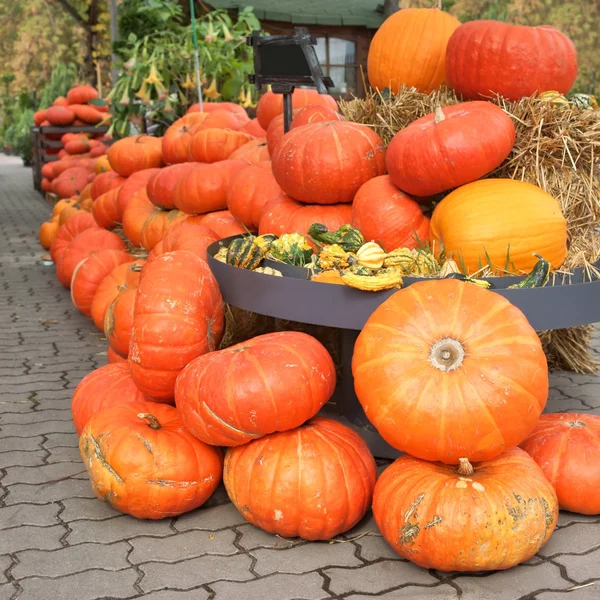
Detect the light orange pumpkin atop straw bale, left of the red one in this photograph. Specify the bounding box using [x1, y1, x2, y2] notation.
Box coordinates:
[367, 8, 460, 94]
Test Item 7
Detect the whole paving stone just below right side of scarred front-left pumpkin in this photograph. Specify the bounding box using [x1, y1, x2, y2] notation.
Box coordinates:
[129, 529, 237, 564]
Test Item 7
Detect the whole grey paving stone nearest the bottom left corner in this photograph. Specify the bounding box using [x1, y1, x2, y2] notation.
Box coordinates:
[12, 542, 130, 580]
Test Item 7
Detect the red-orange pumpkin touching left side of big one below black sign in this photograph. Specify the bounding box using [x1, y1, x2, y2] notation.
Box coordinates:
[227, 162, 283, 231]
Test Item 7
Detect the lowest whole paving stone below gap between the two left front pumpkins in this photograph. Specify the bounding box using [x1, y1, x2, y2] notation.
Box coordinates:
[139, 554, 254, 600]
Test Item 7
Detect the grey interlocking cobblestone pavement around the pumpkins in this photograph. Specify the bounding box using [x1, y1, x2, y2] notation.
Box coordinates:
[0, 159, 600, 600]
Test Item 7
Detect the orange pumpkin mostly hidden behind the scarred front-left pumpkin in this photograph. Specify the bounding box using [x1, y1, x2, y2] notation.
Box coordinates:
[71, 363, 147, 435]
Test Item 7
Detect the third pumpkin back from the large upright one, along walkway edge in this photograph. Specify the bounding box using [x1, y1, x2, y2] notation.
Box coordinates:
[71, 250, 131, 317]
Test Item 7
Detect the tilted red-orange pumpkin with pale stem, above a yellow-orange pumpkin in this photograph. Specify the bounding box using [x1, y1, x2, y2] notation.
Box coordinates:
[386, 102, 516, 196]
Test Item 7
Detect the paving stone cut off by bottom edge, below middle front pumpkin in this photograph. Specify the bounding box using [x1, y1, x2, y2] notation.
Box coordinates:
[210, 573, 331, 600]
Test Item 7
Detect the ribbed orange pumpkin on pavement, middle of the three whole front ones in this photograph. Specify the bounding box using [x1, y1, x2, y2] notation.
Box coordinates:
[223, 417, 376, 540]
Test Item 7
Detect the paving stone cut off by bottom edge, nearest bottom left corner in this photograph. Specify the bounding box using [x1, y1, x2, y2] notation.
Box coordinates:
[19, 569, 138, 600]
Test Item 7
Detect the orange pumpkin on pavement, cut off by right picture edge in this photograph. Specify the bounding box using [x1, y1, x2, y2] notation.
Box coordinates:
[521, 413, 600, 515]
